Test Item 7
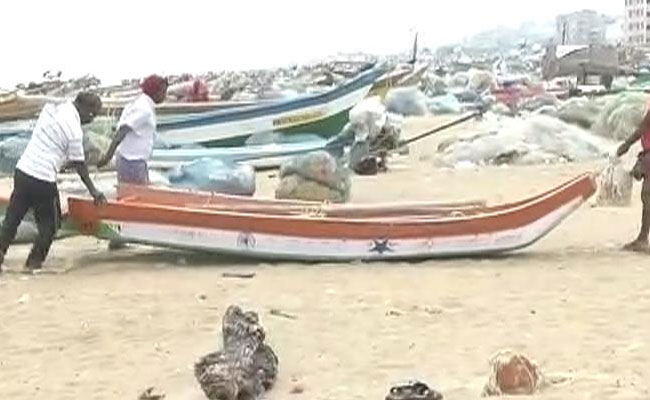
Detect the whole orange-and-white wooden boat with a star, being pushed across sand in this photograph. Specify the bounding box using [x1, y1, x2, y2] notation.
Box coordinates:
[12, 174, 596, 261]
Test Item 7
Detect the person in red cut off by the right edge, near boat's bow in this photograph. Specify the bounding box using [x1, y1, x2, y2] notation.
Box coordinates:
[616, 102, 650, 253]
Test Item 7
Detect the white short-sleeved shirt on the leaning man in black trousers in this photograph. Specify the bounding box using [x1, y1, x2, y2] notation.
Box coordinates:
[16, 101, 84, 182]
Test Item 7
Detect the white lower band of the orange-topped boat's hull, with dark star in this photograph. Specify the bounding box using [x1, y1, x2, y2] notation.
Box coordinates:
[104, 199, 582, 261]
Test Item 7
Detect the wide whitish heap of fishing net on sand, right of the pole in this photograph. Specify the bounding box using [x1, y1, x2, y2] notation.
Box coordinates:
[435, 115, 614, 167]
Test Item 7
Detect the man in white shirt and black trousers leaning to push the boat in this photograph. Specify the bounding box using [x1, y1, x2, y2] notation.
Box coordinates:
[0, 93, 106, 272]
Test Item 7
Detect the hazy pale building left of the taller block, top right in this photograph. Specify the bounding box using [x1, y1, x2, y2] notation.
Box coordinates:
[555, 9, 612, 45]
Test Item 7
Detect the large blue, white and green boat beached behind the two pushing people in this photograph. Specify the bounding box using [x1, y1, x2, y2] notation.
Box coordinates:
[153, 66, 385, 147]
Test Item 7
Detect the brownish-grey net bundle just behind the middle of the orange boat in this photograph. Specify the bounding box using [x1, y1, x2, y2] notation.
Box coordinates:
[275, 150, 351, 203]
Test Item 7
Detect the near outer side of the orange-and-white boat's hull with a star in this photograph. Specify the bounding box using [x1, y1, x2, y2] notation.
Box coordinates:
[68, 174, 596, 261]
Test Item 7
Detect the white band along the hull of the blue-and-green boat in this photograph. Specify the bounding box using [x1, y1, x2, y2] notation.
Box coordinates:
[159, 86, 370, 145]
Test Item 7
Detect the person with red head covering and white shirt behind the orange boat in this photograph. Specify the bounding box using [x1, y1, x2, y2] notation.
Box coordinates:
[97, 75, 168, 185]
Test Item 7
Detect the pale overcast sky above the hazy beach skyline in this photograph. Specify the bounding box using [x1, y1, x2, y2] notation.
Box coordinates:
[0, 0, 624, 88]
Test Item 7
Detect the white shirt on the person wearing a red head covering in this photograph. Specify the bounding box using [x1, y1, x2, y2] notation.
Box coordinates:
[117, 93, 156, 161]
